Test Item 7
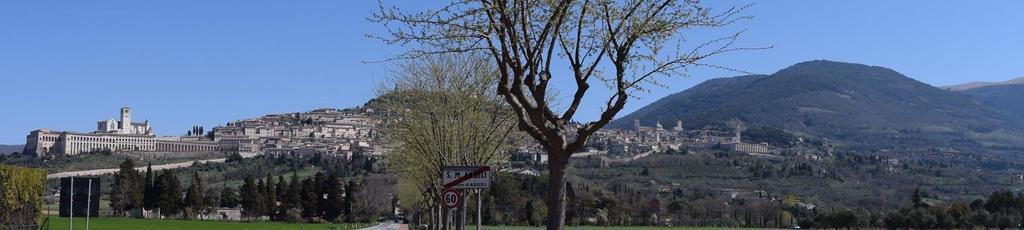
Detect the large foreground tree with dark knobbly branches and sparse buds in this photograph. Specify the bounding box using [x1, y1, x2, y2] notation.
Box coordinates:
[370, 0, 757, 229]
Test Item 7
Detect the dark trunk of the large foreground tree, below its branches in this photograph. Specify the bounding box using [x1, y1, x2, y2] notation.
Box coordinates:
[548, 150, 569, 230]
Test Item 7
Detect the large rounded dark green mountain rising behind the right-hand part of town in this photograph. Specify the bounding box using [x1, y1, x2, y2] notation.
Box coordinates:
[609, 60, 1024, 149]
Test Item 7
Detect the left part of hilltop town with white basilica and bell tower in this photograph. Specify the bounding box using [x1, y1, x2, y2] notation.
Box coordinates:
[24, 106, 383, 157]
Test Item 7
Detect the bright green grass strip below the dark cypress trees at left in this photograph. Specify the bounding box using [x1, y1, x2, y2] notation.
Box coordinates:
[43, 217, 371, 230]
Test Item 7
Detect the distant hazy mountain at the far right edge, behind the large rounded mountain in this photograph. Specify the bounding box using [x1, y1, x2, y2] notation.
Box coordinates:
[959, 84, 1024, 119]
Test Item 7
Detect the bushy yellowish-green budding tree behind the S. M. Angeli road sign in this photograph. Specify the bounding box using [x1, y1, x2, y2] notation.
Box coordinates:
[374, 53, 523, 227]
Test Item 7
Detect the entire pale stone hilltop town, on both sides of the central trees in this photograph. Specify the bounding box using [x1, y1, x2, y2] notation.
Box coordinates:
[24, 106, 831, 172]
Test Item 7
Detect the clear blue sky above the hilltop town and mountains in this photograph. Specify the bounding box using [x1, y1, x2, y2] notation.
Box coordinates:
[0, 0, 1024, 144]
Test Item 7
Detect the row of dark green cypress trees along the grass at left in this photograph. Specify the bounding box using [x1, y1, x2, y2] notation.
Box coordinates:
[109, 158, 376, 223]
